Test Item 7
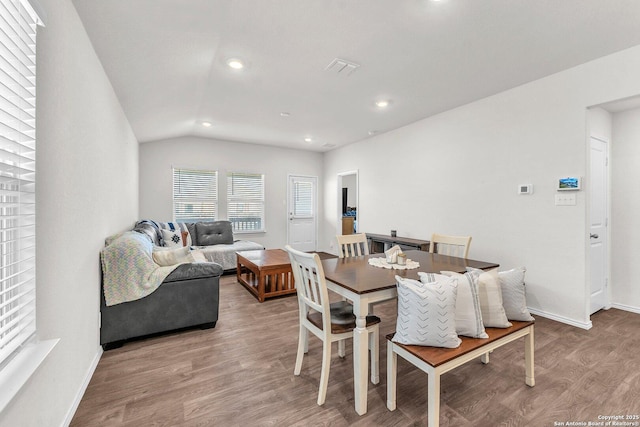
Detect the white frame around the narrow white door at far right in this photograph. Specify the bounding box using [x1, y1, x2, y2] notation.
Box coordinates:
[585, 134, 612, 319]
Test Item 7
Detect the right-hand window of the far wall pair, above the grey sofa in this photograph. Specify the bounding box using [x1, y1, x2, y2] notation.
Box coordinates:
[227, 172, 265, 233]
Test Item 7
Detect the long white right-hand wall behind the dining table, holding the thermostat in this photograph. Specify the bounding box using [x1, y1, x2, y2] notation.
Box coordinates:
[323, 47, 640, 328]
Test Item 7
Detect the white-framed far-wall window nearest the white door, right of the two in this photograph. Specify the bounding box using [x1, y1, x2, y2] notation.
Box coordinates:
[227, 172, 266, 234]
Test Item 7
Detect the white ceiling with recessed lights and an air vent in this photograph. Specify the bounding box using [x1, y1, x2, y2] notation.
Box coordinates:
[73, 0, 640, 151]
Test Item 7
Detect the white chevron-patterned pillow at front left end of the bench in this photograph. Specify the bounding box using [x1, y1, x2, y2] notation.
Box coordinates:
[393, 276, 462, 348]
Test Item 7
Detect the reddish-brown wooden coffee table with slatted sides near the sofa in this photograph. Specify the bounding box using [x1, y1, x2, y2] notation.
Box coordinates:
[236, 249, 296, 302]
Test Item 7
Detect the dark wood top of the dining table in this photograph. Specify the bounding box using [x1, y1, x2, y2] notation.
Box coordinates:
[322, 250, 499, 294]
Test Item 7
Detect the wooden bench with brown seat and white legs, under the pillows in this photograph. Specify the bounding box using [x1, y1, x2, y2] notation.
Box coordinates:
[387, 321, 535, 427]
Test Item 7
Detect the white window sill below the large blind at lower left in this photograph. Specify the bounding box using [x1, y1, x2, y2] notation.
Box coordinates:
[0, 339, 60, 412]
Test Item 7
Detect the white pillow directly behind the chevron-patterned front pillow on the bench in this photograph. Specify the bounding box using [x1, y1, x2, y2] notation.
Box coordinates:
[418, 272, 489, 338]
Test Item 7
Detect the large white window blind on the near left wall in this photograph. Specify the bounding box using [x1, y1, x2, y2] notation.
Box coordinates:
[0, 0, 38, 364]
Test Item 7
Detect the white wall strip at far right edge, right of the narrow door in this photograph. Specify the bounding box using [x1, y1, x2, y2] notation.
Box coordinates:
[610, 109, 640, 313]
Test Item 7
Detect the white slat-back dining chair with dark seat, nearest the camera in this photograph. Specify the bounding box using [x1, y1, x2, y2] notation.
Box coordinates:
[285, 245, 380, 405]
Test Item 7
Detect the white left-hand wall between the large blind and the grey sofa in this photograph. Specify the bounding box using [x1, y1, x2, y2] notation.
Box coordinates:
[0, 0, 138, 427]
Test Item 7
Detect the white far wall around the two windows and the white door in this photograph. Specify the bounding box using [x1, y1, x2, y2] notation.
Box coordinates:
[140, 137, 322, 248]
